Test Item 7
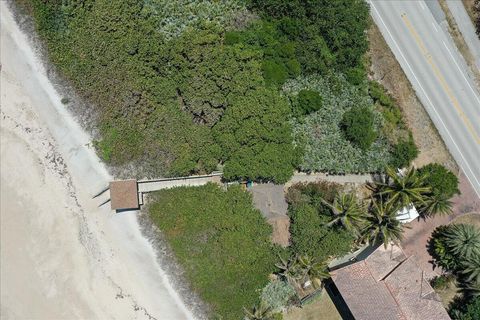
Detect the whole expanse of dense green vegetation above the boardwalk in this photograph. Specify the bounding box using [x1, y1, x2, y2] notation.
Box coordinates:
[23, 0, 408, 182]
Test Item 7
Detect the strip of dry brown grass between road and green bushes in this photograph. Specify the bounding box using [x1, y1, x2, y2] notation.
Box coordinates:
[368, 23, 458, 172]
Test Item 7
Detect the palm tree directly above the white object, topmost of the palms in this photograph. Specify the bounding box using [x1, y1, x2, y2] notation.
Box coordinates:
[375, 167, 431, 207]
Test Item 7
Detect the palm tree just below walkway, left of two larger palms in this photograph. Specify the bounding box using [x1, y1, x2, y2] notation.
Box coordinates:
[322, 193, 366, 234]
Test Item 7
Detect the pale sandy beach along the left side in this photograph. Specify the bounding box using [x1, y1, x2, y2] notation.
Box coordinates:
[0, 1, 193, 319]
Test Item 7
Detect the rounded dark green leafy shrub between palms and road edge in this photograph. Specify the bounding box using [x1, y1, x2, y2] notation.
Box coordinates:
[418, 163, 460, 198]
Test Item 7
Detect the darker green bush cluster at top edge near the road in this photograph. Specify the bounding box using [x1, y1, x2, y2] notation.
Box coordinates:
[250, 0, 370, 77]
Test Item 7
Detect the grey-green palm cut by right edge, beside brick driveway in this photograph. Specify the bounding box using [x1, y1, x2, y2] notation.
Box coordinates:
[443, 223, 480, 260]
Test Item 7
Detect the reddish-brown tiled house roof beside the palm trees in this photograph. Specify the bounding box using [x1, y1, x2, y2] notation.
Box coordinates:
[332, 245, 450, 320]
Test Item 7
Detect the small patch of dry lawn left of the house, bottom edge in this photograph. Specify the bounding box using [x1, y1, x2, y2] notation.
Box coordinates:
[283, 290, 342, 320]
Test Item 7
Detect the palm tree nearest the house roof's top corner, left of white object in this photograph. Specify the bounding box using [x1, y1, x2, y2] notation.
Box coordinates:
[360, 197, 403, 247]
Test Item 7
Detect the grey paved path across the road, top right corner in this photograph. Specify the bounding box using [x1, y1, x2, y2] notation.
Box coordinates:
[447, 0, 480, 69]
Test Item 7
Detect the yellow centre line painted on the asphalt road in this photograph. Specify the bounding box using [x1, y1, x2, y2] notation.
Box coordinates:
[401, 13, 480, 144]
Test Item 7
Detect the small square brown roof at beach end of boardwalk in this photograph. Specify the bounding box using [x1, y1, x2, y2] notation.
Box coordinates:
[110, 179, 138, 210]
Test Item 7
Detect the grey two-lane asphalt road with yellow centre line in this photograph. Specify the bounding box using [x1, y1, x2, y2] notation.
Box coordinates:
[369, 0, 480, 197]
